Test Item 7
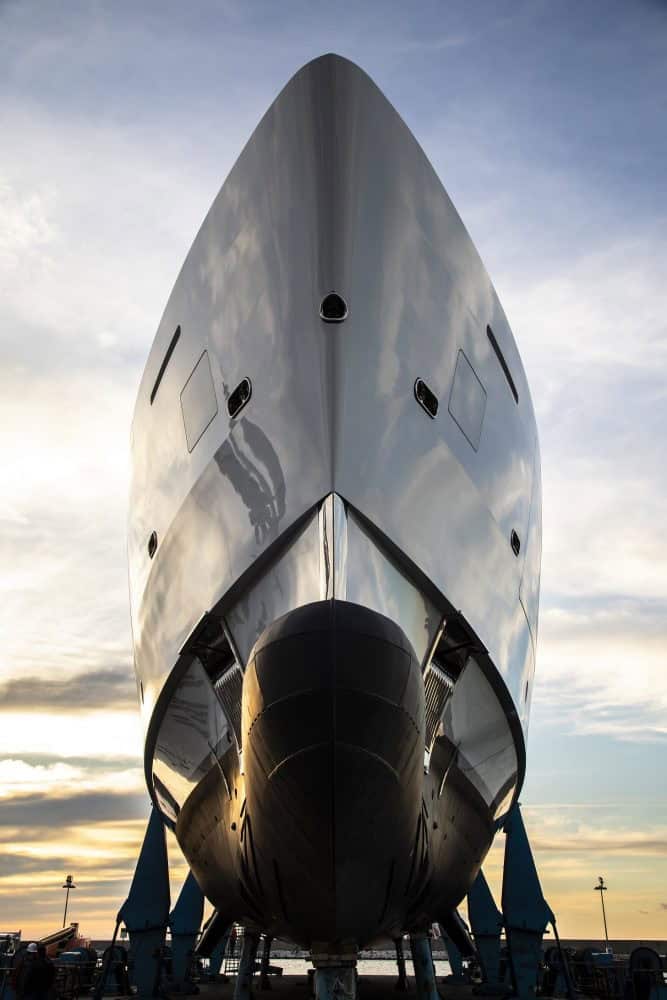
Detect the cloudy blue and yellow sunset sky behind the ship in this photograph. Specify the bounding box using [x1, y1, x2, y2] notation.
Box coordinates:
[0, 0, 667, 939]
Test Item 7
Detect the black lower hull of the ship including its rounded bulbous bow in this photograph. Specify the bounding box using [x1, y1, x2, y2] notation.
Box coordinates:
[176, 601, 493, 950]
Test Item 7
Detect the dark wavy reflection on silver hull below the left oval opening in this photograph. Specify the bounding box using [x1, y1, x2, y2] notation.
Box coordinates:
[215, 417, 285, 543]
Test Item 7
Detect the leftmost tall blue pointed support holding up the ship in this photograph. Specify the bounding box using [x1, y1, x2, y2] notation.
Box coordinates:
[118, 808, 170, 998]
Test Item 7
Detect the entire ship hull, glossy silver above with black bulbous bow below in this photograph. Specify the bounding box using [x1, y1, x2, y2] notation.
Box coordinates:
[129, 56, 541, 950]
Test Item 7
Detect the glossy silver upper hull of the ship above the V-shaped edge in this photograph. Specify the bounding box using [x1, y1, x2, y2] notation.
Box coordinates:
[129, 59, 535, 723]
